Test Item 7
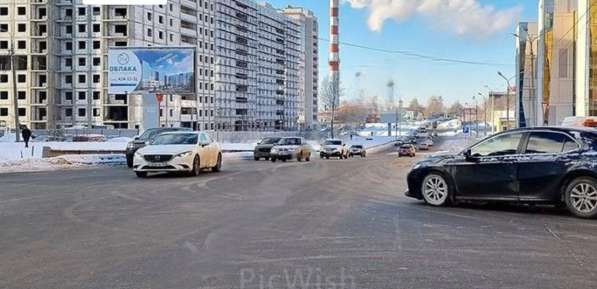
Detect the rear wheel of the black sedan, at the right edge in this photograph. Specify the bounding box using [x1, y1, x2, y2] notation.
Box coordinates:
[565, 177, 597, 219]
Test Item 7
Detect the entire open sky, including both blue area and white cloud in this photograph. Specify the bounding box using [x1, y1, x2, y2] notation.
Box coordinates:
[268, 0, 538, 105]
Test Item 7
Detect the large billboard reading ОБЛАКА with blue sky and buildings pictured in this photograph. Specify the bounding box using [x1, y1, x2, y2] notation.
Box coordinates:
[108, 47, 195, 94]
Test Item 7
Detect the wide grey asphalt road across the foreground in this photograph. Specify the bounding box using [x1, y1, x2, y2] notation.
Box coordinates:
[0, 140, 597, 289]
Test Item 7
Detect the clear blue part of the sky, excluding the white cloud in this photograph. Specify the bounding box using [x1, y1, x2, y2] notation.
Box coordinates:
[268, 0, 538, 103]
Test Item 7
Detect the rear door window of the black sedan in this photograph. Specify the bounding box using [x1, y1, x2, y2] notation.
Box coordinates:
[525, 132, 578, 154]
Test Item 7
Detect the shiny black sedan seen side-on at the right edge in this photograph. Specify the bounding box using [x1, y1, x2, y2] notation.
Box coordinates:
[406, 127, 597, 218]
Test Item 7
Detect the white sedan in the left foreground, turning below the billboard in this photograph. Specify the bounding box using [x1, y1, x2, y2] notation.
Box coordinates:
[133, 132, 222, 178]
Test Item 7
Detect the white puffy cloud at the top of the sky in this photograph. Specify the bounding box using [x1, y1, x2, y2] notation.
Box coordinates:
[345, 0, 521, 38]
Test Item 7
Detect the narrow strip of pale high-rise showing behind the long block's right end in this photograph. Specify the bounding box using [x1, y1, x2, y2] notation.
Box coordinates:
[284, 6, 319, 128]
